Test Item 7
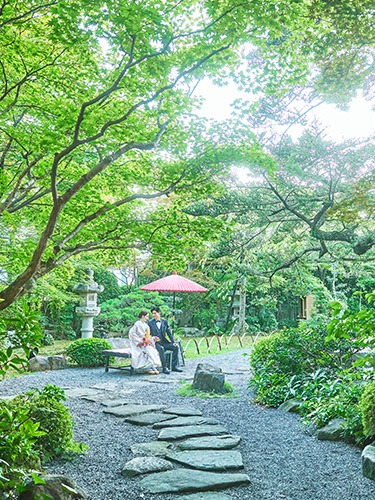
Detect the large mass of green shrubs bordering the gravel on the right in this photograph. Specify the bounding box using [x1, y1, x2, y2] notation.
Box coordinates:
[250, 326, 373, 444]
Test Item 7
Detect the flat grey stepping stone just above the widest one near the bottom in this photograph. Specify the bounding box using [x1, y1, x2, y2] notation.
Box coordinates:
[165, 450, 243, 472]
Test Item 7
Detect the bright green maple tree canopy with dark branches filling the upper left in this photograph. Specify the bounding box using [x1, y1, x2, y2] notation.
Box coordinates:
[0, 0, 373, 310]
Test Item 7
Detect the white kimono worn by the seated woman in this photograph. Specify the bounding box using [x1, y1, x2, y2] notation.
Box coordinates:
[129, 320, 161, 370]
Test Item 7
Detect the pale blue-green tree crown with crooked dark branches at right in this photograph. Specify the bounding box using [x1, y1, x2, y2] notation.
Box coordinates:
[186, 130, 375, 276]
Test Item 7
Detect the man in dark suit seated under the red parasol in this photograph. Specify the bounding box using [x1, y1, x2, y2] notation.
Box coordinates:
[148, 307, 182, 374]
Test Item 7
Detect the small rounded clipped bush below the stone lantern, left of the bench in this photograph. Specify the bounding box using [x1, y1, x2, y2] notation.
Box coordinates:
[66, 337, 112, 367]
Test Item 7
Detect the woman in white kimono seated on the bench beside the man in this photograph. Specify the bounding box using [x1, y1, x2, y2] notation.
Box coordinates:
[129, 311, 161, 375]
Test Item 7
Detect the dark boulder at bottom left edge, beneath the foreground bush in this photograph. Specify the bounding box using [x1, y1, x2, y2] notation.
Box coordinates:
[19, 474, 88, 500]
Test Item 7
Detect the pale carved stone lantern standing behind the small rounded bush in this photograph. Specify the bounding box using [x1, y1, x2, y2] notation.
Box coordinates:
[73, 269, 104, 339]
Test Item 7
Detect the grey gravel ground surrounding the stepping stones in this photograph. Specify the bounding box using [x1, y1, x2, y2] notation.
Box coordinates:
[0, 351, 375, 500]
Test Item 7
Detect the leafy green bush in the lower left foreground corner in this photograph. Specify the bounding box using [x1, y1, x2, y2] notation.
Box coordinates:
[0, 386, 87, 498]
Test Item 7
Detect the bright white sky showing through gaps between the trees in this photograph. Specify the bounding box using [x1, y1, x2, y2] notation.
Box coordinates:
[197, 80, 375, 142]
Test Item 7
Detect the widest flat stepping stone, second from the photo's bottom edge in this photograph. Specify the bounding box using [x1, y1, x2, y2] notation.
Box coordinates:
[139, 469, 250, 493]
